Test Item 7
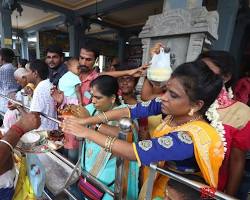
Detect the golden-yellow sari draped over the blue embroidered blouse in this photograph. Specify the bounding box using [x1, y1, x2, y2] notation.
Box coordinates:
[141, 121, 224, 199]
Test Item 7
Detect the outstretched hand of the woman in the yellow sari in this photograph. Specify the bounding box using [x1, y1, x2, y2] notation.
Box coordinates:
[60, 116, 89, 138]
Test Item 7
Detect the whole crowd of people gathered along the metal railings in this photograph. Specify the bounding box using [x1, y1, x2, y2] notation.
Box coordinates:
[0, 44, 250, 200]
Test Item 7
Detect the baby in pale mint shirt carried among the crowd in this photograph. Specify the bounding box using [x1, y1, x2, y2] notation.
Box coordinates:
[58, 58, 82, 105]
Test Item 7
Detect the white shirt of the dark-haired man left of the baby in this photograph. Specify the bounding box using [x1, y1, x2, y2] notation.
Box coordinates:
[30, 79, 58, 130]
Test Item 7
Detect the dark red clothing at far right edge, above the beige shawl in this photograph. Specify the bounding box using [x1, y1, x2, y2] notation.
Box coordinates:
[234, 77, 250, 104]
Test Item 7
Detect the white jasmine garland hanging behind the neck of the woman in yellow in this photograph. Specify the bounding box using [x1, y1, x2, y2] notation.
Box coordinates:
[205, 100, 227, 153]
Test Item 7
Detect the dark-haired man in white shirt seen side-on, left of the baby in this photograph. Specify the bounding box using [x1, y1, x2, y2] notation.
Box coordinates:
[26, 60, 58, 130]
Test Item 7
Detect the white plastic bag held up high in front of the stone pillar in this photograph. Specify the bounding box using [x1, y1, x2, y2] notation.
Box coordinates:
[147, 48, 172, 82]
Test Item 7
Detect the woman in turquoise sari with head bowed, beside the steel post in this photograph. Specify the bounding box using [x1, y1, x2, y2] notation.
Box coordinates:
[77, 75, 139, 200]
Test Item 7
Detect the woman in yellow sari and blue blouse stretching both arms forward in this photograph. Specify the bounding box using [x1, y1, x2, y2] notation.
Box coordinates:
[62, 61, 224, 199]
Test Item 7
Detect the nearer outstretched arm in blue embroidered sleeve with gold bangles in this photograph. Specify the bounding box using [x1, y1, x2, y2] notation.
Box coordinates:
[61, 117, 194, 165]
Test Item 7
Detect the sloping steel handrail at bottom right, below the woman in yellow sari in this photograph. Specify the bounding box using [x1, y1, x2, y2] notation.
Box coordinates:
[150, 164, 236, 200]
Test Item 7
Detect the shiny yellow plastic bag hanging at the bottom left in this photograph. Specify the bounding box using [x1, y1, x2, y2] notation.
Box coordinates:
[13, 156, 36, 200]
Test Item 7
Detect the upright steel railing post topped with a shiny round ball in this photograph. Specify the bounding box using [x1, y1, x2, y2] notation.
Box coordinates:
[114, 118, 132, 200]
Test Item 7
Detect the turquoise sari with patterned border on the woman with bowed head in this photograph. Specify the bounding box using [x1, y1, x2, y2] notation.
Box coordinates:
[81, 104, 139, 200]
